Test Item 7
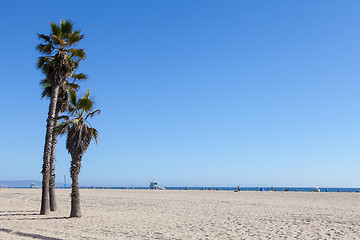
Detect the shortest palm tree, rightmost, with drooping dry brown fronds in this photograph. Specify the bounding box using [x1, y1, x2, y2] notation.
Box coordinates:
[55, 90, 100, 217]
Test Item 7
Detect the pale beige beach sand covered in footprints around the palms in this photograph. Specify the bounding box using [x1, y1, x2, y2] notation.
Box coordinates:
[0, 189, 360, 240]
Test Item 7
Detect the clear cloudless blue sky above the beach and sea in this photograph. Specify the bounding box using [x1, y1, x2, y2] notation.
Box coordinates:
[0, 0, 360, 187]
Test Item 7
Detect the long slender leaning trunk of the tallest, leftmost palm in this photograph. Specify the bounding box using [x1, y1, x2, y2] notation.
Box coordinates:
[40, 86, 59, 215]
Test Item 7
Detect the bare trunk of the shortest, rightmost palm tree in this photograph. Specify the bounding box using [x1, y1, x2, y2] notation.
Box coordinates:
[70, 155, 82, 217]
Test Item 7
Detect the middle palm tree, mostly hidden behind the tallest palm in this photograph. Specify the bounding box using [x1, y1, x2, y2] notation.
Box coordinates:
[40, 73, 87, 211]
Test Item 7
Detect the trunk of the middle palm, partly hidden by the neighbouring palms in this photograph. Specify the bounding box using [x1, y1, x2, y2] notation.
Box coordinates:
[49, 107, 61, 212]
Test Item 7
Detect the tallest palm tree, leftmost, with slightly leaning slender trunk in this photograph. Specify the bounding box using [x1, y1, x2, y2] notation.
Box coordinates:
[37, 20, 86, 214]
